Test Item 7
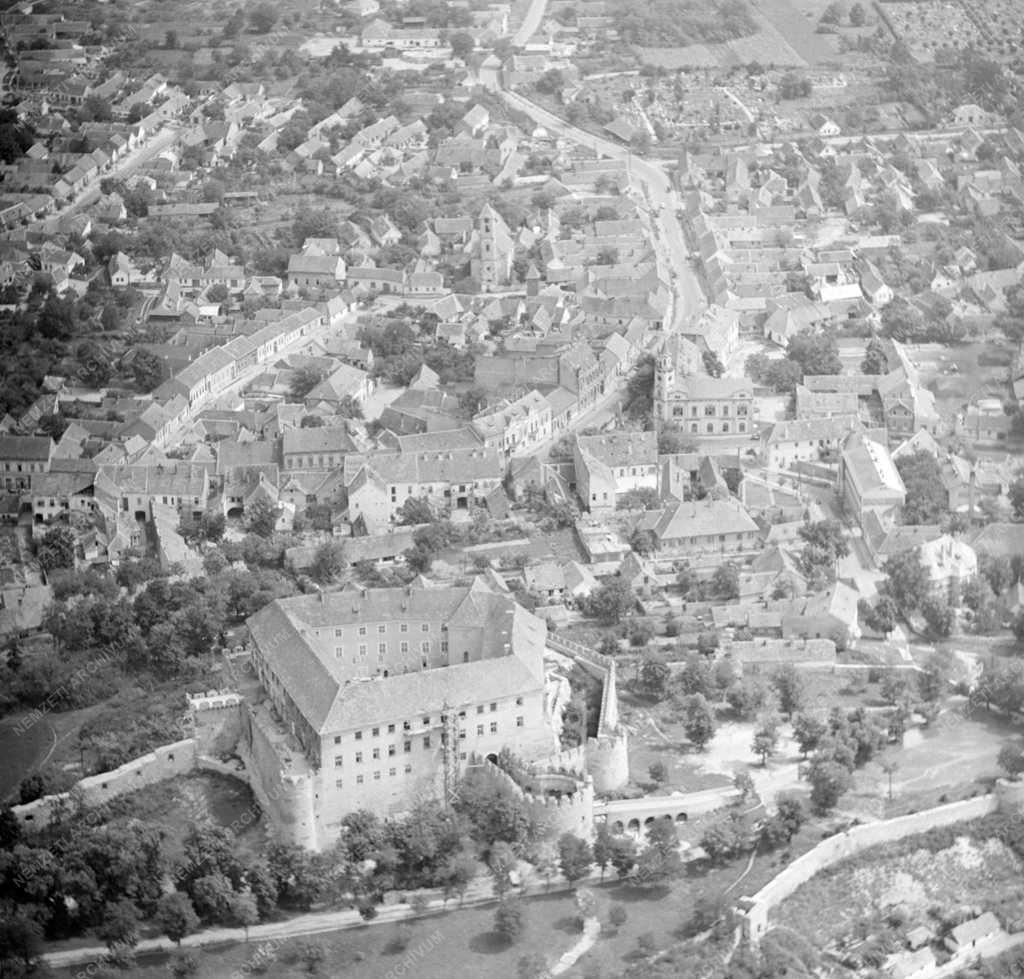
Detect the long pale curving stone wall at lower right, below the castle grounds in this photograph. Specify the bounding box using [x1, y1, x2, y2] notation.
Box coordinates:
[742, 788, 995, 942]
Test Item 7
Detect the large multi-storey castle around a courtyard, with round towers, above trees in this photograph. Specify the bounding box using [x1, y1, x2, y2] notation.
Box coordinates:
[239, 578, 628, 849]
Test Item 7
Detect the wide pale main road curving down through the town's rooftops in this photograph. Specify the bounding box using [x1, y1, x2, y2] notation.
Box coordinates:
[500, 89, 707, 329]
